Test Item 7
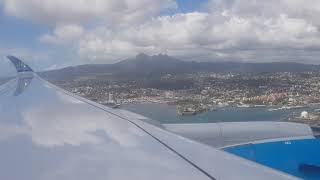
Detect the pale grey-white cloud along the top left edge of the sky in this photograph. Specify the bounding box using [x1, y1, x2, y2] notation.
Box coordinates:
[4, 0, 176, 25]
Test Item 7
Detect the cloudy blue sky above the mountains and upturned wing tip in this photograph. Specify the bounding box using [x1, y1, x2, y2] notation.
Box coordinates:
[0, 0, 320, 70]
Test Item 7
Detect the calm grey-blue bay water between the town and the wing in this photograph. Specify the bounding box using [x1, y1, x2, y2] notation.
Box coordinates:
[121, 104, 305, 123]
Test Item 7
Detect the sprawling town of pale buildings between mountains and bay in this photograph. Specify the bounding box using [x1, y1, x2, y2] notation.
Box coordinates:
[64, 72, 320, 114]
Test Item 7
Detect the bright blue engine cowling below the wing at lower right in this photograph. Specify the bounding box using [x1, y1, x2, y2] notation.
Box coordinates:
[225, 139, 320, 180]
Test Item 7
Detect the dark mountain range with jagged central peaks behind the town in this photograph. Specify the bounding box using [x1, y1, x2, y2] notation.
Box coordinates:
[40, 54, 320, 79]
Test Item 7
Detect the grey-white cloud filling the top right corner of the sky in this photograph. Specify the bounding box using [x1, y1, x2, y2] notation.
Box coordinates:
[208, 0, 320, 25]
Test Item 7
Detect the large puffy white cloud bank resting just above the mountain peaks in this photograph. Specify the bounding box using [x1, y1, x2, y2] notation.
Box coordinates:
[79, 11, 320, 62]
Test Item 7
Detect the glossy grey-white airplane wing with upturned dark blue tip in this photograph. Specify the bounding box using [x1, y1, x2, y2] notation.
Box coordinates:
[0, 56, 308, 180]
